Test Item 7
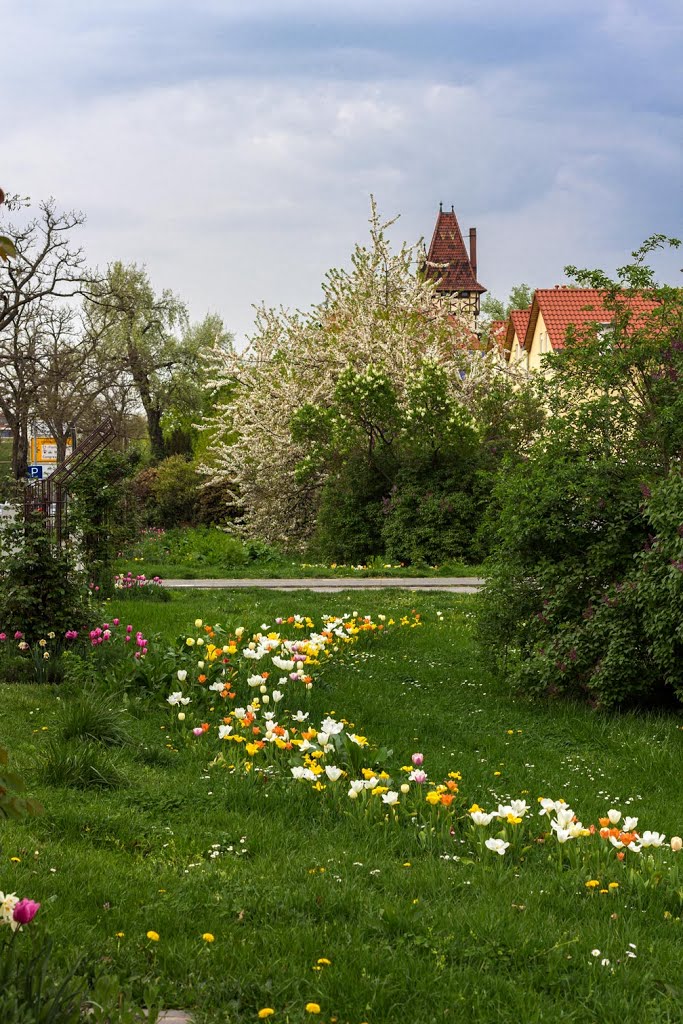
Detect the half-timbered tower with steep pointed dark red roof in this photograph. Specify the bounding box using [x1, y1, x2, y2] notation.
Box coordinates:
[425, 203, 486, 322]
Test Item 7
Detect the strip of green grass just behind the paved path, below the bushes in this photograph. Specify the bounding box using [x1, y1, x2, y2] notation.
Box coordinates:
[116, 526, 482, 580]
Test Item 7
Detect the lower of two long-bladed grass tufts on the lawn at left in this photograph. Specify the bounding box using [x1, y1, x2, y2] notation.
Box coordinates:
[39, 739, 128, 790]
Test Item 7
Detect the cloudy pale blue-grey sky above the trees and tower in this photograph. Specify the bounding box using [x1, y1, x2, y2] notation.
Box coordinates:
[0, 0, 683, 342]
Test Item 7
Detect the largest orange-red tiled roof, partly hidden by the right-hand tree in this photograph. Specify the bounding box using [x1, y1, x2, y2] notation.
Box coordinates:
[519, 286, 656, 349]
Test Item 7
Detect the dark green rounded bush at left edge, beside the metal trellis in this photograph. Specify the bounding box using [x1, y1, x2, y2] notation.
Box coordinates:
[0, 520, 90, 643]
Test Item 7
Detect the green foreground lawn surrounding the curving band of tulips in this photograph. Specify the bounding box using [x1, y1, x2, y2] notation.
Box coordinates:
[0, 589, 683, 1024]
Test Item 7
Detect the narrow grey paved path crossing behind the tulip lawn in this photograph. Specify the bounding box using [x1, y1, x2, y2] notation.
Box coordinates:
[164, 577, 483, 594]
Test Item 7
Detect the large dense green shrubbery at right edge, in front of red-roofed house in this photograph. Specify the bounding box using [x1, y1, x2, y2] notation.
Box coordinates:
[478, 235, 683, 708]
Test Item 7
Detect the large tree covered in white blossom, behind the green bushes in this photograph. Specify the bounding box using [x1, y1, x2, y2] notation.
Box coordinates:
[200, 201, 495, 543]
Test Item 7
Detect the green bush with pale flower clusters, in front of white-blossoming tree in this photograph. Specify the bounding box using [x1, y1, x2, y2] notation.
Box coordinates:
[292, 360, 528, 564]
